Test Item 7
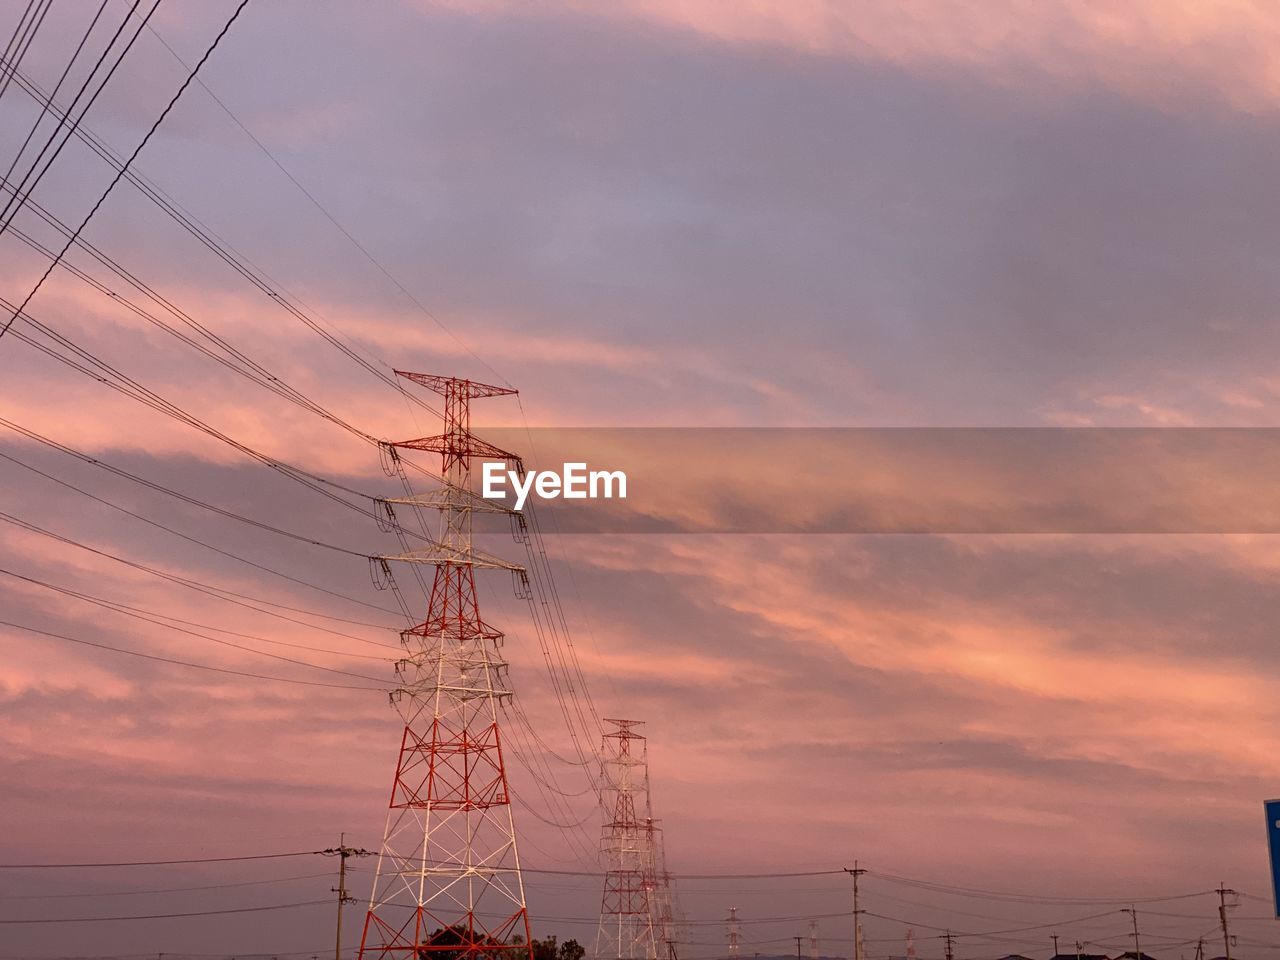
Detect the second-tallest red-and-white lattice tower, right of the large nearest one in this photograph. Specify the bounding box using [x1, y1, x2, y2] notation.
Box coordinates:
[595, 718, 660, 960]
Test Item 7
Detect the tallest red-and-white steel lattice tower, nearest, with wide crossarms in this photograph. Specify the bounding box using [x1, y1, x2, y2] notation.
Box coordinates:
[360, 371, 532, 960]
